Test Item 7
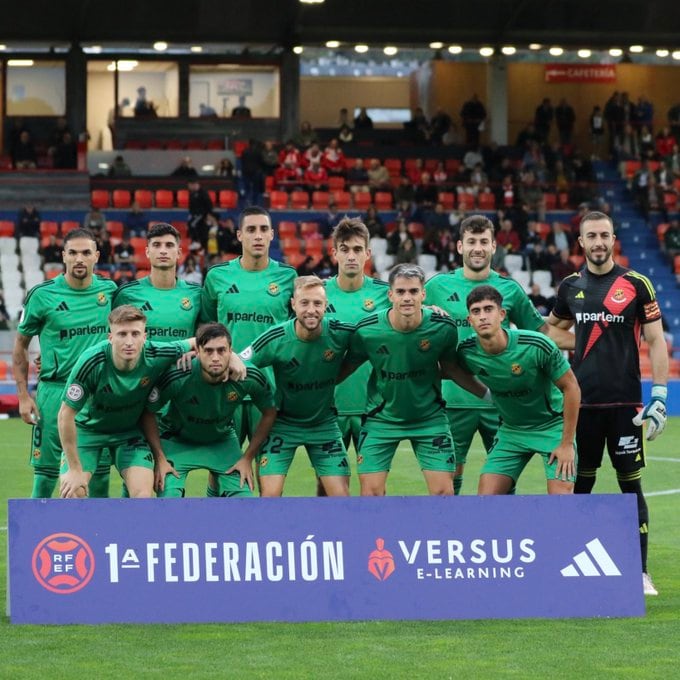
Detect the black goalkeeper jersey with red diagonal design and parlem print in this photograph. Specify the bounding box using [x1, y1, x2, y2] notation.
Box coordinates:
[553, 265, 661, 407]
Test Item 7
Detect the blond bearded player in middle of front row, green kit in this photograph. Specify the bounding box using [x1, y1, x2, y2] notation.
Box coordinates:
[240, 276, 354, 496]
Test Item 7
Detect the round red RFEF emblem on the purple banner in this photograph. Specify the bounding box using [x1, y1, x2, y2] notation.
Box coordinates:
[31, 533, 94, 595]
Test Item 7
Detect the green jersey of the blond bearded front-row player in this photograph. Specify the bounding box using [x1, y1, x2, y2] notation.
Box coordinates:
[241, 317, 354, 426]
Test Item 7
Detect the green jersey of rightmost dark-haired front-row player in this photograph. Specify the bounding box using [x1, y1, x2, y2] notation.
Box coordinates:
[458, 328, 569, 431]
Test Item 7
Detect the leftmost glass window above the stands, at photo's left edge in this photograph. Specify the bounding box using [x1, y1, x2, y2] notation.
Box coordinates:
[5, 59, 66, 116]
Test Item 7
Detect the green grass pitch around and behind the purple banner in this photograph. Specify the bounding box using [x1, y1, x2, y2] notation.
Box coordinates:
[0, 418, 680, 680]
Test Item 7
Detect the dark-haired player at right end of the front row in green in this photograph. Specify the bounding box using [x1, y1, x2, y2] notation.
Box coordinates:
[458, 286, 581, 495]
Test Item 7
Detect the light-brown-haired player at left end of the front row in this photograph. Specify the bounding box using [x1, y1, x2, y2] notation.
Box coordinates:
[59, 305, 194, 498]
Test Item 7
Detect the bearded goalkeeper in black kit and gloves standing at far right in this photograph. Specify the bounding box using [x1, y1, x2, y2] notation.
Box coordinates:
[549, 212, 668, 595]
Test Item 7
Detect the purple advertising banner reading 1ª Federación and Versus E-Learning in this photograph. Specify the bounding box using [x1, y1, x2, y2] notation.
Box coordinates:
[8, 494, 645, 624]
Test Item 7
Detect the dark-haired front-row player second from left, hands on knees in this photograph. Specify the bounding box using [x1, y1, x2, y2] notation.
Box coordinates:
[143, 323, 276, 498]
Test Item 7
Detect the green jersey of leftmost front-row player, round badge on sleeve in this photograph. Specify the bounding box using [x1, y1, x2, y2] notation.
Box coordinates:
[62, 340, 190, 434]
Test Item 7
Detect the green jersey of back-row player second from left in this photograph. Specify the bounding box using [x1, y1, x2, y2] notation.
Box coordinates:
[112, 276, 201, 342]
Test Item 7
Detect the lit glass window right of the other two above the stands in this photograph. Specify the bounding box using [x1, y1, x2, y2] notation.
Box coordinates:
[189, 64, 280, 118]
